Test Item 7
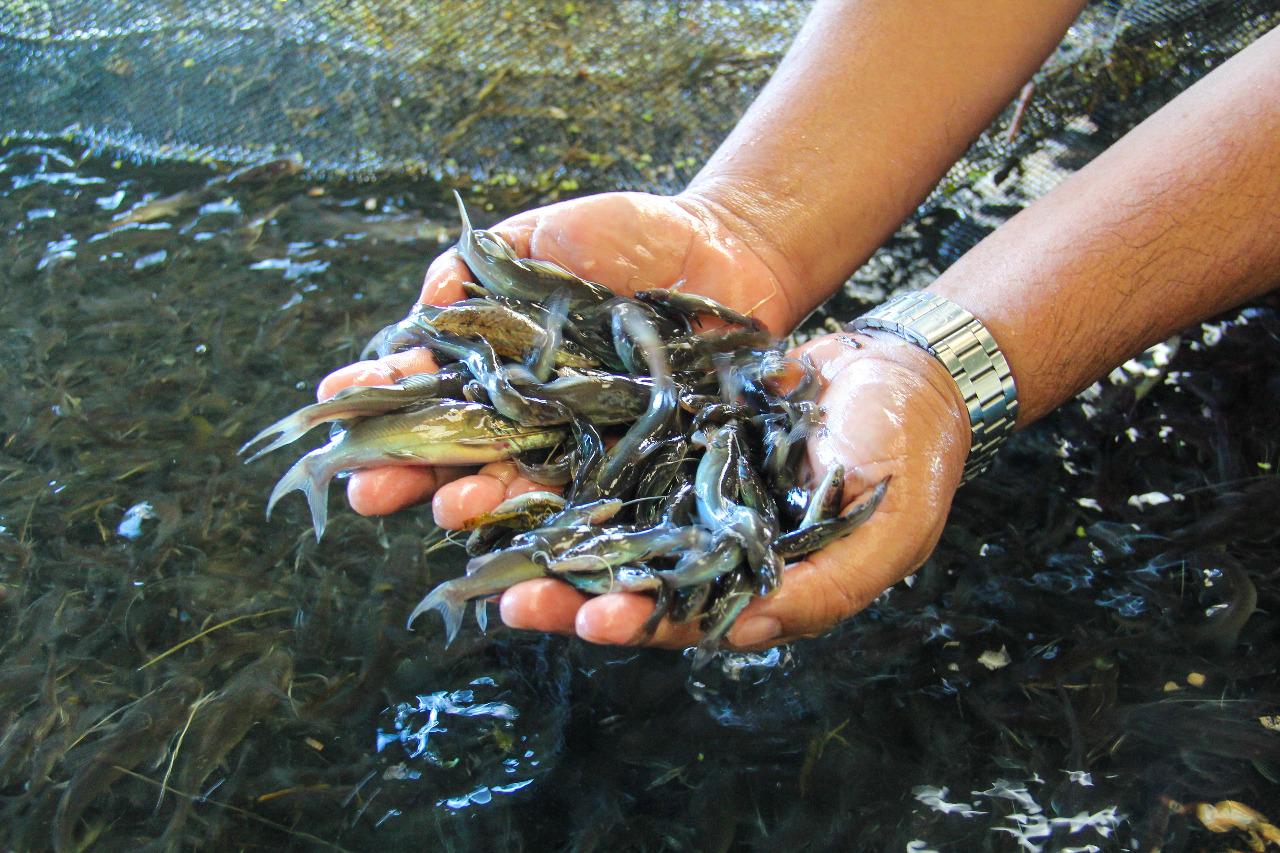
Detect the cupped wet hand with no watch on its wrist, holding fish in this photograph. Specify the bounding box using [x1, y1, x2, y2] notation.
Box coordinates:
[317, 192, 800, 529]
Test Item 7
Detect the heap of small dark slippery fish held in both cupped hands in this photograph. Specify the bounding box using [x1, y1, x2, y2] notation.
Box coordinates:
[241, 197, 887, 669]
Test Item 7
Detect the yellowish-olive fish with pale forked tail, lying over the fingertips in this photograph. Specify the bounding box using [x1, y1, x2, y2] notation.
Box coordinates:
[266, 401, 567, 539]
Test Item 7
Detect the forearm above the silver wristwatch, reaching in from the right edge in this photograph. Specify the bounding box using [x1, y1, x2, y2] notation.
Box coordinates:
[929, 29, 1280, 424]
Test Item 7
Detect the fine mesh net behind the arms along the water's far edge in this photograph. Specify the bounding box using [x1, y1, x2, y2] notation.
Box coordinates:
[0, 0, 1280, 206]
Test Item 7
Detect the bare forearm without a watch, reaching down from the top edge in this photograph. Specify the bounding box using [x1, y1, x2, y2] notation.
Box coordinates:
[685, 0, 1083, 321]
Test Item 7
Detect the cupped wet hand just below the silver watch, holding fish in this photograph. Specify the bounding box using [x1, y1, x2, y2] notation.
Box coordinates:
[502, 333, 969, 648]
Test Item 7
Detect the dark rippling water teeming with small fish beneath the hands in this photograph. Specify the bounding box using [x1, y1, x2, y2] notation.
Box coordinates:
[0, 143, 1280, 850]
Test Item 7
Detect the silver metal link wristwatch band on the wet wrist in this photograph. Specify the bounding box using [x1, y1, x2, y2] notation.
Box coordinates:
[845, 291, 1018, 483]
